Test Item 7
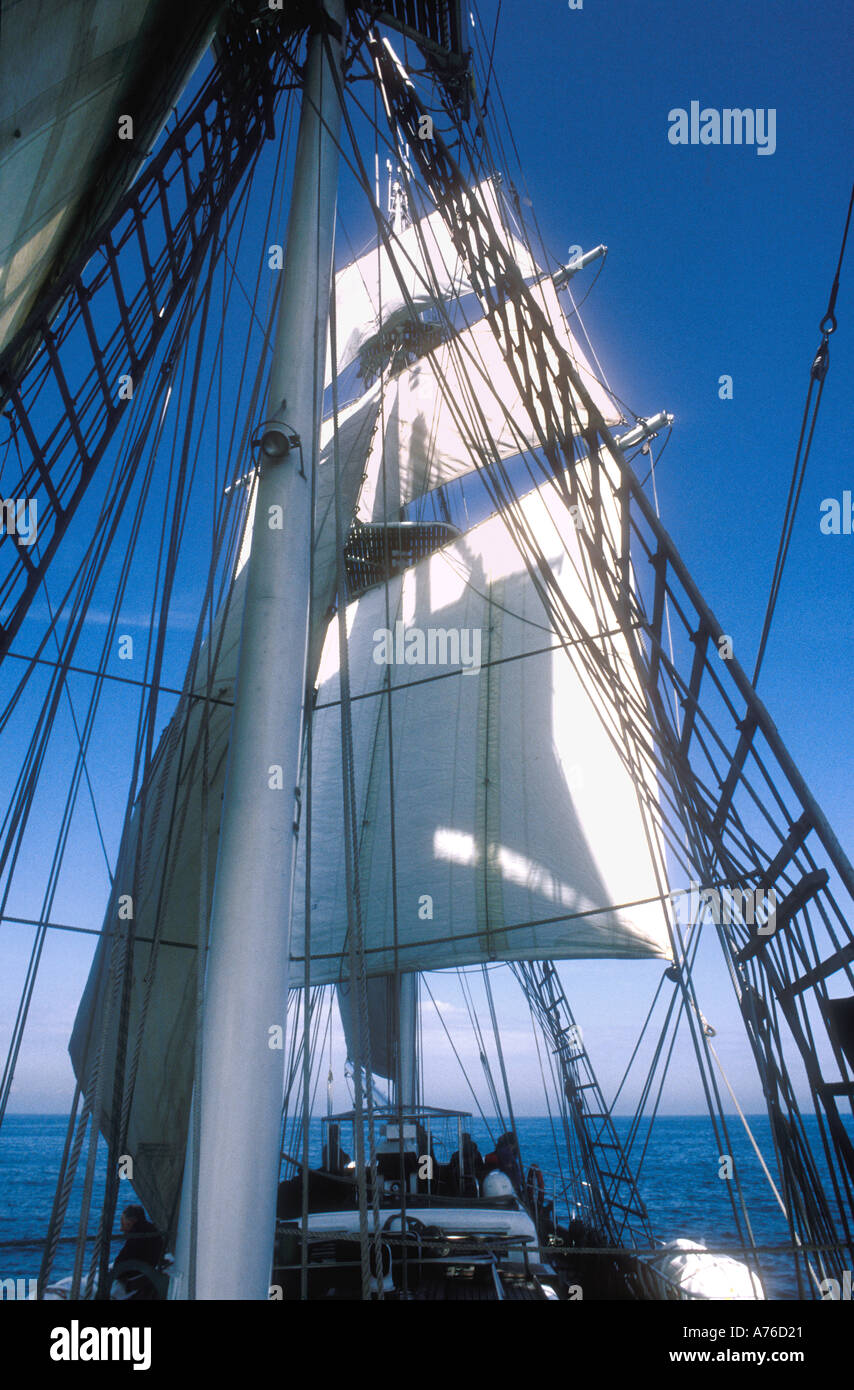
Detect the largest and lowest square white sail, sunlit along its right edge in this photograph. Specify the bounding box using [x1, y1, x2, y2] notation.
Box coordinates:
[292, 472, 669, 984]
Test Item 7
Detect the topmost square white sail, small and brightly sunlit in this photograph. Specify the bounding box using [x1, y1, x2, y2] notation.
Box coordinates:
[327, 179, 538, 385]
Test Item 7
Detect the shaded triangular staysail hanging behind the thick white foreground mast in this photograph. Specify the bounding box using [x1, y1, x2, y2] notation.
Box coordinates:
[70, 378, 378, 1230]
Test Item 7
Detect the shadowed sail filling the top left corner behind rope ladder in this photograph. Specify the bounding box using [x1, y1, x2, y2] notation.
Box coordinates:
[0, 0, 217, 349]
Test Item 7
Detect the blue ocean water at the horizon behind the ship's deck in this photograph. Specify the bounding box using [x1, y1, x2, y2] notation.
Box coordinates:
[0, 1115, 851, 1298]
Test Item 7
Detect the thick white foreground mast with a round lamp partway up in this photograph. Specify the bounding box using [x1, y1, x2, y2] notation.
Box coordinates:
[177, 0, 345, 1300]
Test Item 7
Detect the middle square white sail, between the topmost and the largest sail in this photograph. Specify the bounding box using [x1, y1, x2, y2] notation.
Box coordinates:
[359, 277, 620, 521]
